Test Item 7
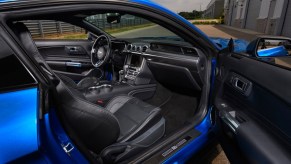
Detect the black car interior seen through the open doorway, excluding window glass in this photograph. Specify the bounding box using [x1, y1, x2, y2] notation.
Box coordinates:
[7, 11, 208, 163]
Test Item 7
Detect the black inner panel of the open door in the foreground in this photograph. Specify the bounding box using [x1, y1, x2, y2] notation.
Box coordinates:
[214, 54, 291, 163]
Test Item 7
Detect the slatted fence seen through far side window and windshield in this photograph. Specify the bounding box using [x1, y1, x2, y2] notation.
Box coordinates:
[22, 18, 149, 38]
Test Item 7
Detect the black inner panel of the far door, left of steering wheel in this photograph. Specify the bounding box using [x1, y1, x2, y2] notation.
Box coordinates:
[35, 40, 102, 81]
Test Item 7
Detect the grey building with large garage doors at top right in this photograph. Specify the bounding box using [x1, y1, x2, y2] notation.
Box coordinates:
[224, 0, 291, 37]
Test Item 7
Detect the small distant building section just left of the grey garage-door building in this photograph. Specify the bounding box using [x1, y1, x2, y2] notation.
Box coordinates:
[203, 0, 224, 18]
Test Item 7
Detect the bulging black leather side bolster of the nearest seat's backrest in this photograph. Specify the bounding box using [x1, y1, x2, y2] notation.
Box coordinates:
[56, 82, 120, 153]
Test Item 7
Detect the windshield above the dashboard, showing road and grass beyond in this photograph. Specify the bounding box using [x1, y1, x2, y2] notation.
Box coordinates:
[85, 13, 183, 41]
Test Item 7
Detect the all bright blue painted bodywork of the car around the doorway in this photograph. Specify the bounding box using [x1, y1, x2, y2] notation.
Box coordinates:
[0, 0, 248, 163]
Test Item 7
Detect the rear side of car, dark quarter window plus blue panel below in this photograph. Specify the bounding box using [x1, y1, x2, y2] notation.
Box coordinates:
[0, 34, 42, 163]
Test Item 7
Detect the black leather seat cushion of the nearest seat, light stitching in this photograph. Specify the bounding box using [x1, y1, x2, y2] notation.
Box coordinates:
[106, 95, 162, 142]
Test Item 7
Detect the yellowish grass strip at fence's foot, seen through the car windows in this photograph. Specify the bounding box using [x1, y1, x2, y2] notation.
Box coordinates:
[35, 23, 154, 40]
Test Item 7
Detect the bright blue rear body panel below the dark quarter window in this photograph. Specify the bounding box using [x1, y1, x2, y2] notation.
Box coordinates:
[0, 88, 38, 163]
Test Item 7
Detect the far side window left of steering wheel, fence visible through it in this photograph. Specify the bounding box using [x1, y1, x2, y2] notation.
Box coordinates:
[22, 20, 88, 40]
